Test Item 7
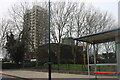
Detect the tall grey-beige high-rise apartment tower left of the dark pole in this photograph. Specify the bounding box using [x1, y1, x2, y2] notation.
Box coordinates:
[23, 5, 48, 58]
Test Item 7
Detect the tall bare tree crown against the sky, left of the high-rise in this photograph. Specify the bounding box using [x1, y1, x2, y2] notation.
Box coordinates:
[8, 2, 30, 33]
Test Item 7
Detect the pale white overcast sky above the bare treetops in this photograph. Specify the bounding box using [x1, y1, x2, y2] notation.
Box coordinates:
[0, 0, 119, 20]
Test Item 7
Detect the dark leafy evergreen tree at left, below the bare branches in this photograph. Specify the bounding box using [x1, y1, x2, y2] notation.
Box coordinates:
[6, 32, 25, 64]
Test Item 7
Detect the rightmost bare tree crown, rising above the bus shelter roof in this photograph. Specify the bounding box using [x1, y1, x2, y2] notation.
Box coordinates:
[85, 5, 115, 58]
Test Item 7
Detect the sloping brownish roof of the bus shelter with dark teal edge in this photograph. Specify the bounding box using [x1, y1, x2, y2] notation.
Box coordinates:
[74, 28, 120, 44]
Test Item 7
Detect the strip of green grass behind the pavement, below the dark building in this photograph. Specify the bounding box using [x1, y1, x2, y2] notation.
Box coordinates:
[31, 64, 116, 72]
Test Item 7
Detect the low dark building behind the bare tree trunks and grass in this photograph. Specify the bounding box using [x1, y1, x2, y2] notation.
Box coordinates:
[38, 43, 83, 64]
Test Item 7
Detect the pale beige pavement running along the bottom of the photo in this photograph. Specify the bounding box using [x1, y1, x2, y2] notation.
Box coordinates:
[2, 70, 117, 80]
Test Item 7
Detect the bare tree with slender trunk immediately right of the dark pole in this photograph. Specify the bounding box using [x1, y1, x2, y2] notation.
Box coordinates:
[52, 2, 76, 64]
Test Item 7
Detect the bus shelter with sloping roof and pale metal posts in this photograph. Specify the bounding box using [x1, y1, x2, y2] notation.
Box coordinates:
[75, 28, 120, 80]
